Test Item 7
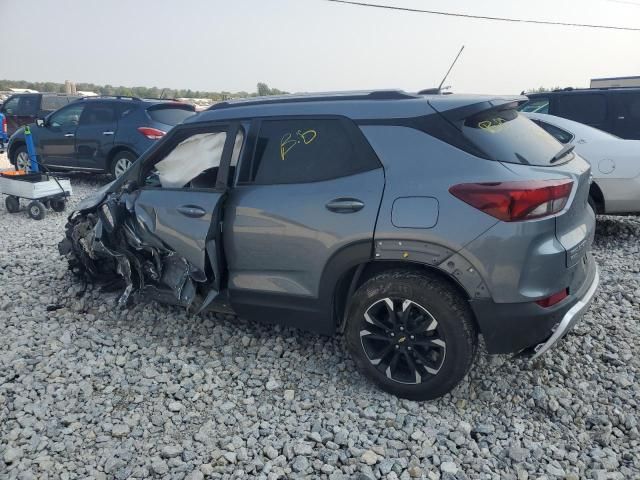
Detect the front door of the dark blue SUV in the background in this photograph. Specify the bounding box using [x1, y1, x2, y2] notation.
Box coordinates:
[32, 101, 85, 169]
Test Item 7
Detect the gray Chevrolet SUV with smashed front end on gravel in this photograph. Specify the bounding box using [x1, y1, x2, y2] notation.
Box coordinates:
[60, 91, 598, 400]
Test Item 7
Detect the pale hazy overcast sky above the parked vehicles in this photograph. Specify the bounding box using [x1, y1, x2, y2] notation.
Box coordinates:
[0, 0, 640, 94]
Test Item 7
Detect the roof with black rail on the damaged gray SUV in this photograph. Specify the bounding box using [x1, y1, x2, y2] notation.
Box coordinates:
[184, 90, 526, 123]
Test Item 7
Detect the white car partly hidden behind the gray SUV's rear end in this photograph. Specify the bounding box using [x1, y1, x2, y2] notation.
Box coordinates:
[525, 113, 640, 214]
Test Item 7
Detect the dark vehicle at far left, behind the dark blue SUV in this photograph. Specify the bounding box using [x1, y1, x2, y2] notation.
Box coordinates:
[0, 93, 80, 136]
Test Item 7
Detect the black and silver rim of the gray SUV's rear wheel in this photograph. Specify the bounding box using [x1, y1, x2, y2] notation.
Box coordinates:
[360, 298, 447, 385]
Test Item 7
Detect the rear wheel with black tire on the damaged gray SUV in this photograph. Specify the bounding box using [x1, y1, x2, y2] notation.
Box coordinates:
[345, 270, 478, 400]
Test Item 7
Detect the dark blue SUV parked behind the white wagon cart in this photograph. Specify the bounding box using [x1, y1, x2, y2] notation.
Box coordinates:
[8, 97, 195, 177]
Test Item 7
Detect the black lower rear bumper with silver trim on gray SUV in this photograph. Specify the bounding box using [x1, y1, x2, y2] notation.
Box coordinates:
[470, 255, 599, 356]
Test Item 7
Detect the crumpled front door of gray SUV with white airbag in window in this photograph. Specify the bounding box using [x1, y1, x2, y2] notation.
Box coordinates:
[134, 124, 236, 291]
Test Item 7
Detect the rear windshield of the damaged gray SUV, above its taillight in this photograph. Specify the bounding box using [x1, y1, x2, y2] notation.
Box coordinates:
[462, 109, 572, 166]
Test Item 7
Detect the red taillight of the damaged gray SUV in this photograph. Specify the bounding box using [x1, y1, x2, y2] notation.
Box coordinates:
[449, 179, 573, 222]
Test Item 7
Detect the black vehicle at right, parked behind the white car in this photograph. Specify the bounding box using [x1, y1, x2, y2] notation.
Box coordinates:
[520, 87, 640, 140]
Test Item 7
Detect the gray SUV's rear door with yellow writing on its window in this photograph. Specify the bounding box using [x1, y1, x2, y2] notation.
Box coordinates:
[224, 117, 384, 333]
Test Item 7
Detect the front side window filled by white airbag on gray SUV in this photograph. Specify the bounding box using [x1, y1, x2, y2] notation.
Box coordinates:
[146, 131, 227, 188]
